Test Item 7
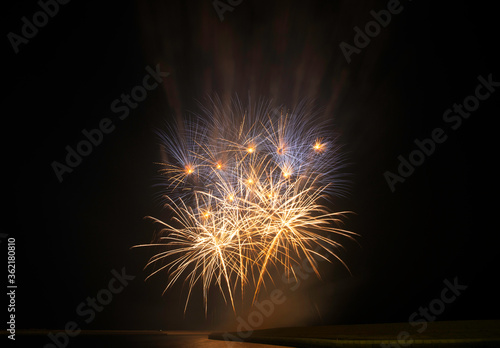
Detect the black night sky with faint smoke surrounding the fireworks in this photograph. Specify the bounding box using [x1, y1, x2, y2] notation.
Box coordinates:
[4, 0, 500, 329]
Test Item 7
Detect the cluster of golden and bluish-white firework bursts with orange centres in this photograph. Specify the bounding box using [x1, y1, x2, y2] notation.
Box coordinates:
[133, 97, 355, 311]
